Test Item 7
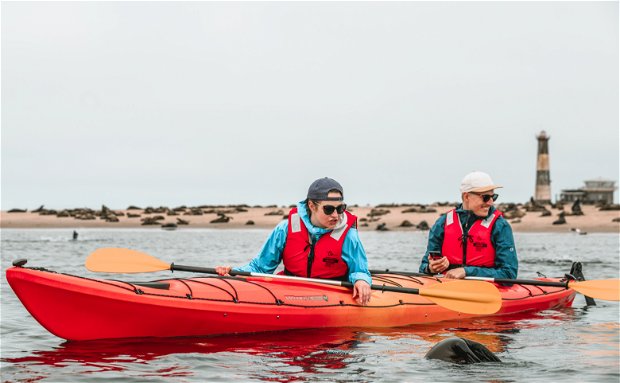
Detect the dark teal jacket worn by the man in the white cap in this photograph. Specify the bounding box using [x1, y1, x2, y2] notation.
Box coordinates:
[420, 204, 519, 279]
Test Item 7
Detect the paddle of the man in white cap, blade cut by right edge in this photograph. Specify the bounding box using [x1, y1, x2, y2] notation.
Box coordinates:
[370, 269, 620, 301]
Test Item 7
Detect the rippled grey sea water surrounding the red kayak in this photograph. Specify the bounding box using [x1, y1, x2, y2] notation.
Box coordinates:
[0, 229, 620, 382]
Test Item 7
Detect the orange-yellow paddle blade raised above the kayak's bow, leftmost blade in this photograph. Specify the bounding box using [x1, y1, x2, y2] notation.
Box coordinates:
[85, 247, 170, 273]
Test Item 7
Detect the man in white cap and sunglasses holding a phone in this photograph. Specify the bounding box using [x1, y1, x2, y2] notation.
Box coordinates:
[420, 171, 519, 279]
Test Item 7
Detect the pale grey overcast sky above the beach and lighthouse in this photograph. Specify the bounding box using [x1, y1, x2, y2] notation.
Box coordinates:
[1, 1, 620, 210]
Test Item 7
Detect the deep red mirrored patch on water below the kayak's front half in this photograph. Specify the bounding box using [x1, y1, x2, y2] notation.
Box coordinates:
[2, 329, 367, 381]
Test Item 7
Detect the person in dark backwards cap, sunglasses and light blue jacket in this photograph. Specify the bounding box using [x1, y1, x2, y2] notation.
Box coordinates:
[215, 177, 372, 305]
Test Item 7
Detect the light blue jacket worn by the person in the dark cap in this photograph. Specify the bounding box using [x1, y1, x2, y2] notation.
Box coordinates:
[235, 201, 372, 285]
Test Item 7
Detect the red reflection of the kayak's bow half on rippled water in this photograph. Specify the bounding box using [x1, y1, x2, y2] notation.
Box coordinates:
[0, 329, 369, 381]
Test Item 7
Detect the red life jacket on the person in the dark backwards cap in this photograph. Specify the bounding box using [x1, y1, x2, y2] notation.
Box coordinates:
[282, 207, 357, 279]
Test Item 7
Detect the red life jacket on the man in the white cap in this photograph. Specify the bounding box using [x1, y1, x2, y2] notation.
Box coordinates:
[441, 209, 502, 267]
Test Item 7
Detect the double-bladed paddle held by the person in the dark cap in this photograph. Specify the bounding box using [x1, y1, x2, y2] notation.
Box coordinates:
[85, 248, 502, 315]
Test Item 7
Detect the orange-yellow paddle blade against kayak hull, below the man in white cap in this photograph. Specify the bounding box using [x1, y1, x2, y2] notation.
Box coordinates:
[420, 280, 502, 315]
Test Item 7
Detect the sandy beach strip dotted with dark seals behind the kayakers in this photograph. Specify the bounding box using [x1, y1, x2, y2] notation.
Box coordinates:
[0, 204, 620, 233]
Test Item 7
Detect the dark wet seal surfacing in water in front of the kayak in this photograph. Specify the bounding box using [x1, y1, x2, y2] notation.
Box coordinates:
[425, 337, 501, 364]
